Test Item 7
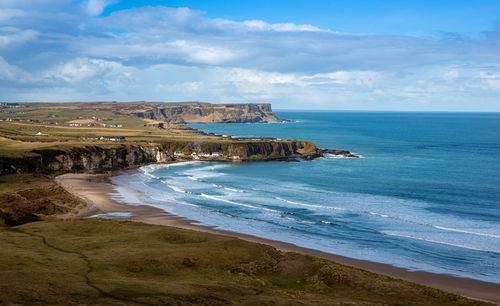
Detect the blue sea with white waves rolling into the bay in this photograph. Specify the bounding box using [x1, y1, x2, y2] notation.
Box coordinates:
[113, 112, 500, 283]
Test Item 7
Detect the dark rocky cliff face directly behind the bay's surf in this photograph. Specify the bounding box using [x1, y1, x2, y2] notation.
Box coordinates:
[0, 141, 317, 175]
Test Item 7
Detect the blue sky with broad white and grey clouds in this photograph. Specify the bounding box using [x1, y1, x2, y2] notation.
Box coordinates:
[0, 0, 500, 112]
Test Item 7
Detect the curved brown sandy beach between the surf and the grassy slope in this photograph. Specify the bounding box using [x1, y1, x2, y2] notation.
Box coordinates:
[55, 169, 500, 304]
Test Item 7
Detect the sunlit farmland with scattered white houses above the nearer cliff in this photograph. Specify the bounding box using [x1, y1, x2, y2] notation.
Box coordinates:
[0, 103, 220, 146]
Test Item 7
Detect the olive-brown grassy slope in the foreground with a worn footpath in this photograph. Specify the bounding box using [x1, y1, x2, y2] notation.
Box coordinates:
[0, 219, 481, 305]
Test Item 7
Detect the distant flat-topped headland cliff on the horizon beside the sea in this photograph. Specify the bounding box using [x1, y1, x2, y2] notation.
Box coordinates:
[120, 102, 281, 123]
